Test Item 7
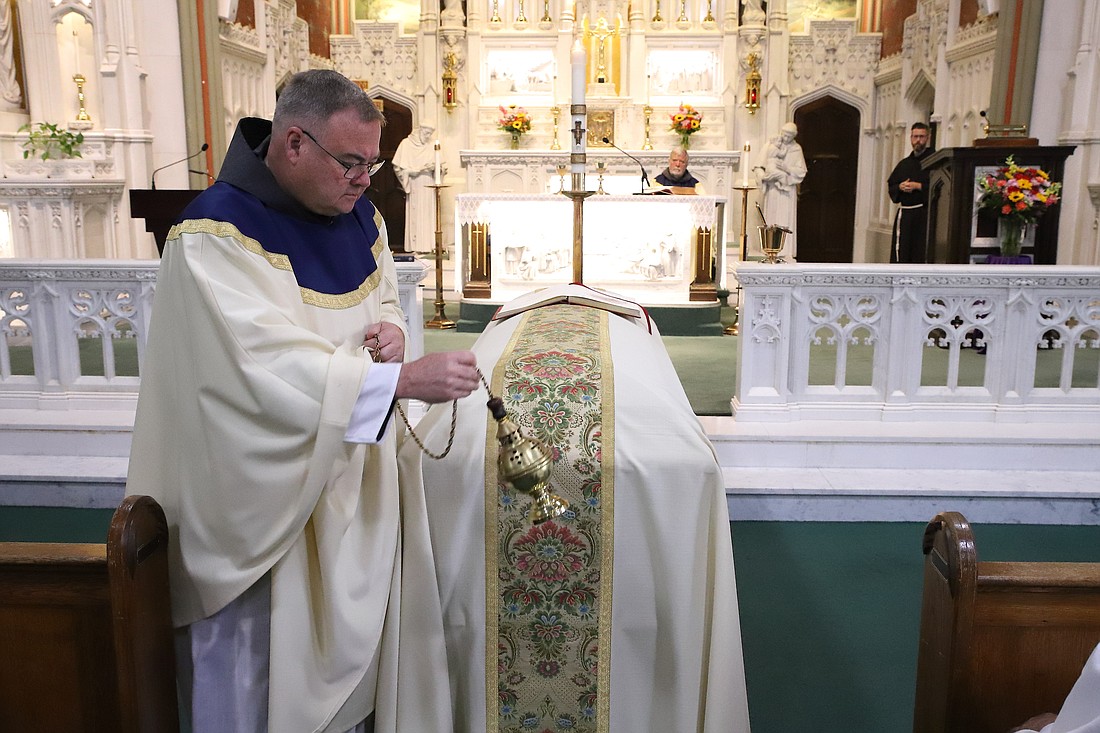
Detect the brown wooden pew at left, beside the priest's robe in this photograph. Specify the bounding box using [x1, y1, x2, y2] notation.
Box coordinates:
[0, 496, 179, 733]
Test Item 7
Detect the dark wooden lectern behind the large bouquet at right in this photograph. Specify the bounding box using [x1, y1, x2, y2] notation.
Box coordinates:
[921, 144, 1075, 264]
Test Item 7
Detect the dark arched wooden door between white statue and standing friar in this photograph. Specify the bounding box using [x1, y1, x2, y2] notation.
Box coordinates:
[794, 97, 859, 262]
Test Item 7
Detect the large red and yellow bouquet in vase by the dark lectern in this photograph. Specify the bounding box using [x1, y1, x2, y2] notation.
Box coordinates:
[978, 155, 1062, 256]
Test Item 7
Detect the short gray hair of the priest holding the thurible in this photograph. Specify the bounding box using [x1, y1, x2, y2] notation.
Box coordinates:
[272, 68, 386, 129]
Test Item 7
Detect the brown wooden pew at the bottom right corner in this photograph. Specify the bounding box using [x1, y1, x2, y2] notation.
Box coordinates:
[913, 512, 1100, 733]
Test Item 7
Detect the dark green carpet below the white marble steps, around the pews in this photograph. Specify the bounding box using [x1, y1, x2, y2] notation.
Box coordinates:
[0, 507, 1100, 733]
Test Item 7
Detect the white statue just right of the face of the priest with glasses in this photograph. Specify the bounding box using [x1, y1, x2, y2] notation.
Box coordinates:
[393, 125, 436, 252]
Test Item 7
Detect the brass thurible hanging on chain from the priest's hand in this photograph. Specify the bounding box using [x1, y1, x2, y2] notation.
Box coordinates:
[486, 397, 569, 524]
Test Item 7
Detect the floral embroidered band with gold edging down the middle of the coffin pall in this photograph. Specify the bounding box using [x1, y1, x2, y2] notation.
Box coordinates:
[485, 305, 615, 733]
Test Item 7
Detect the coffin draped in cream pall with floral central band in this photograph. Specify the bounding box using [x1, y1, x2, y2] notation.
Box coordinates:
[403, 285, 749, 733]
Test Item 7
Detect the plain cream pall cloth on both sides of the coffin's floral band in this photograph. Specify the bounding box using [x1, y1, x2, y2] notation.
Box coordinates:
[405, 286, 749, 733]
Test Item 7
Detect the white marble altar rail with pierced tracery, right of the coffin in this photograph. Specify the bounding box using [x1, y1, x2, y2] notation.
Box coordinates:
[733, 263, 1100, 422]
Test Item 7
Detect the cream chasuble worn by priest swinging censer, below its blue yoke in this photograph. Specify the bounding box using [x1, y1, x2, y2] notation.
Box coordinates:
[128, 219, 450, 733]
